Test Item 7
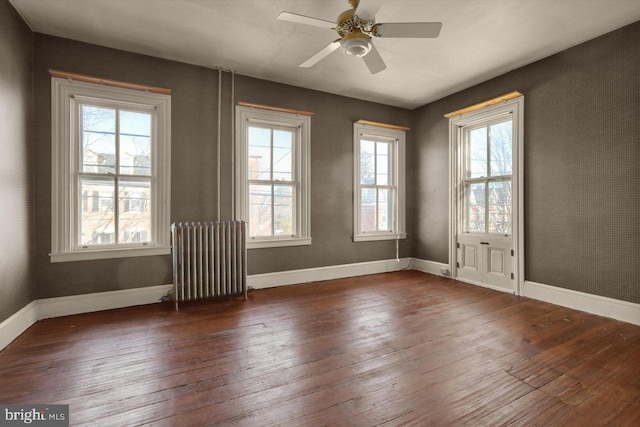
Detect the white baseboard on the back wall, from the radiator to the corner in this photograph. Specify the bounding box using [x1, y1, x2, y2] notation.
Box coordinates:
[247, 258, 411, 289]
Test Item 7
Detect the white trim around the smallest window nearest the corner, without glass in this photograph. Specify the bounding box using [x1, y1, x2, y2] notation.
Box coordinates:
[353, 123, 407, 242]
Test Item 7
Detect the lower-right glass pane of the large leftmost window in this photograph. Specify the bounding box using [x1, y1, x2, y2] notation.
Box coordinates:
[118, 180, 151, 243]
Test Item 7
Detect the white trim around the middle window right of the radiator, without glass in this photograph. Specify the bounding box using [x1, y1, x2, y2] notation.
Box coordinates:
[235, 105, 311, 249]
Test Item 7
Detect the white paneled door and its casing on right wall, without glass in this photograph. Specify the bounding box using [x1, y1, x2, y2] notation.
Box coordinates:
[449, 96, 524, 294]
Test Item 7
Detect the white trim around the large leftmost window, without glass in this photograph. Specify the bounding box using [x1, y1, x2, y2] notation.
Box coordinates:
[50, 77, 171, 262]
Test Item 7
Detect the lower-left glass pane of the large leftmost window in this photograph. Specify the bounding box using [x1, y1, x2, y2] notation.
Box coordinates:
[78, 178, 115, 246]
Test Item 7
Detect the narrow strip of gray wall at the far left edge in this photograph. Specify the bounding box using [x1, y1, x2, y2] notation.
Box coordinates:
[0, 0, 35, 322]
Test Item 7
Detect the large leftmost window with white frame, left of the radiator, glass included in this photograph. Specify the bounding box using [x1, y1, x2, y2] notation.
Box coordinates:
[51, 77, 171, 262]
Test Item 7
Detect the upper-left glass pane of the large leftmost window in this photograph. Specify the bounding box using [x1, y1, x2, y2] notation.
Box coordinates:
[80, 105, 116, 174]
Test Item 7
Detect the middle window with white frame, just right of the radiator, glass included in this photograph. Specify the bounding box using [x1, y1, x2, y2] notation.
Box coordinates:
[236, 106, 311, 248]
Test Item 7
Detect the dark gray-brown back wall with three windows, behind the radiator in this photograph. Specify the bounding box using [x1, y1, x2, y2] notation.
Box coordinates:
[34, 34, 413, 298]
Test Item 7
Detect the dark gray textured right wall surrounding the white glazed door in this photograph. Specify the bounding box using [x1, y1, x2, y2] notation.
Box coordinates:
[413, 22, 640, 303]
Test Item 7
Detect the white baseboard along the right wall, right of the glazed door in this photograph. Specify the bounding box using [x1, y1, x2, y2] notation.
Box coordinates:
[522, 281, 640, 325]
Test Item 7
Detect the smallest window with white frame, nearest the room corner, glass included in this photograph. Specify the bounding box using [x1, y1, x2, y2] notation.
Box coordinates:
[353, 123, 406, 242]
